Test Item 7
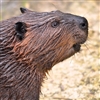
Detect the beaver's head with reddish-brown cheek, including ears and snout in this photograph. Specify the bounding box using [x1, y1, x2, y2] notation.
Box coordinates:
[14, 8, 88, 71]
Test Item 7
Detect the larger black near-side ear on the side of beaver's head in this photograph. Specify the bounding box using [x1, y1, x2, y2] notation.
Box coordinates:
[15, 22, 27, 40]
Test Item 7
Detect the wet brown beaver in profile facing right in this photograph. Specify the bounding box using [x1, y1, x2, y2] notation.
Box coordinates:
[0, 8, 88, 100]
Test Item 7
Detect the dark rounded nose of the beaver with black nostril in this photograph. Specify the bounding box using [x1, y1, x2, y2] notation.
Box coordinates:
[79, 17, 88, 30]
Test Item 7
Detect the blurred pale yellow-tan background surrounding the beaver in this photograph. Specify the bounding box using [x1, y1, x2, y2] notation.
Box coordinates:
[0, 0, 100, 100]
